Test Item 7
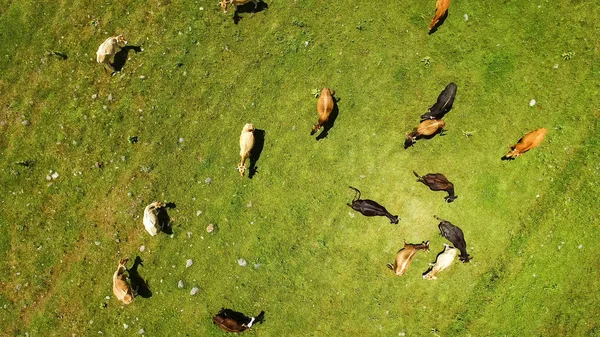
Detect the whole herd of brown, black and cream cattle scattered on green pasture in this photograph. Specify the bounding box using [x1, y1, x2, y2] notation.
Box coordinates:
[102, 0, 547, 332]
